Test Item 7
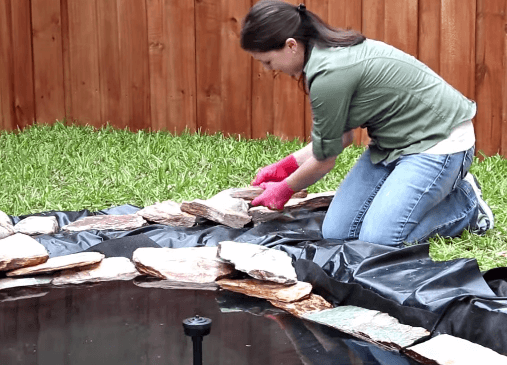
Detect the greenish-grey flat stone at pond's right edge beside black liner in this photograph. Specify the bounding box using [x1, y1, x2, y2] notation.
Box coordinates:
[302, 306, 430, 351]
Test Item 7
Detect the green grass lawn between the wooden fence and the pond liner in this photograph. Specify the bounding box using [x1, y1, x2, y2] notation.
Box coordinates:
[0, 122, 507, 270]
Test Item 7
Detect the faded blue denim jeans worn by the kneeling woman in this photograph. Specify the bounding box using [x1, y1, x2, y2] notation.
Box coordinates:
[322, 147, 478, 246]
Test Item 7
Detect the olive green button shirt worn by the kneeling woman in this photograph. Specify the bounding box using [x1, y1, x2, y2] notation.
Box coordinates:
[304, 39, 476, 163]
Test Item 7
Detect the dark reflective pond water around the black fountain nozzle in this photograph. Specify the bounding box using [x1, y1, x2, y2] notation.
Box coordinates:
[0, 281, 415, 365]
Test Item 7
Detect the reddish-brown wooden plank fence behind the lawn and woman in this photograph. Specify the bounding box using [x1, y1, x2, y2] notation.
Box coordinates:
[0, 0, 507, 156]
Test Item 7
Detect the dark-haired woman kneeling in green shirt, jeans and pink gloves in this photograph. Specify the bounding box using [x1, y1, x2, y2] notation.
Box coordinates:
[241, 0, 493, 245]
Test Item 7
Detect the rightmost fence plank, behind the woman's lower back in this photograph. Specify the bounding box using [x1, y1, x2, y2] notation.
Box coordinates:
[475, 0, 507, 155]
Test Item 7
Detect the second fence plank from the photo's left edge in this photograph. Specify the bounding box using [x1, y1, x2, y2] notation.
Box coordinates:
[11, 0, 35, 128]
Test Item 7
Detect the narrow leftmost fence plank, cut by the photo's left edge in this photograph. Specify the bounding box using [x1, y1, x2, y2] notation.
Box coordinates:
[0, 0, 16, 130]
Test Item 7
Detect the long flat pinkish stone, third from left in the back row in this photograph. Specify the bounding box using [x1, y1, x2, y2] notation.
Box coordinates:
[62, 214, 147, 232]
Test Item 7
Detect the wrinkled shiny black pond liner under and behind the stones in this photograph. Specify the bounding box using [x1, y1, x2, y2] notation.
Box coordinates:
[5, 205, 507, 355]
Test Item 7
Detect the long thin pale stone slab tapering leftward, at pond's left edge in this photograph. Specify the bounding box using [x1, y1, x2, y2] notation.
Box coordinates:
[7, 252, 104, 276]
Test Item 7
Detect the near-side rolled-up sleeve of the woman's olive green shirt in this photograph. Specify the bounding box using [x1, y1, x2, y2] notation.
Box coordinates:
[310, 70, 357, 160]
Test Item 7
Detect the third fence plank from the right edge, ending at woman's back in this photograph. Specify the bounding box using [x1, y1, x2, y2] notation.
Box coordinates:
[418, 0, 441, 73]
